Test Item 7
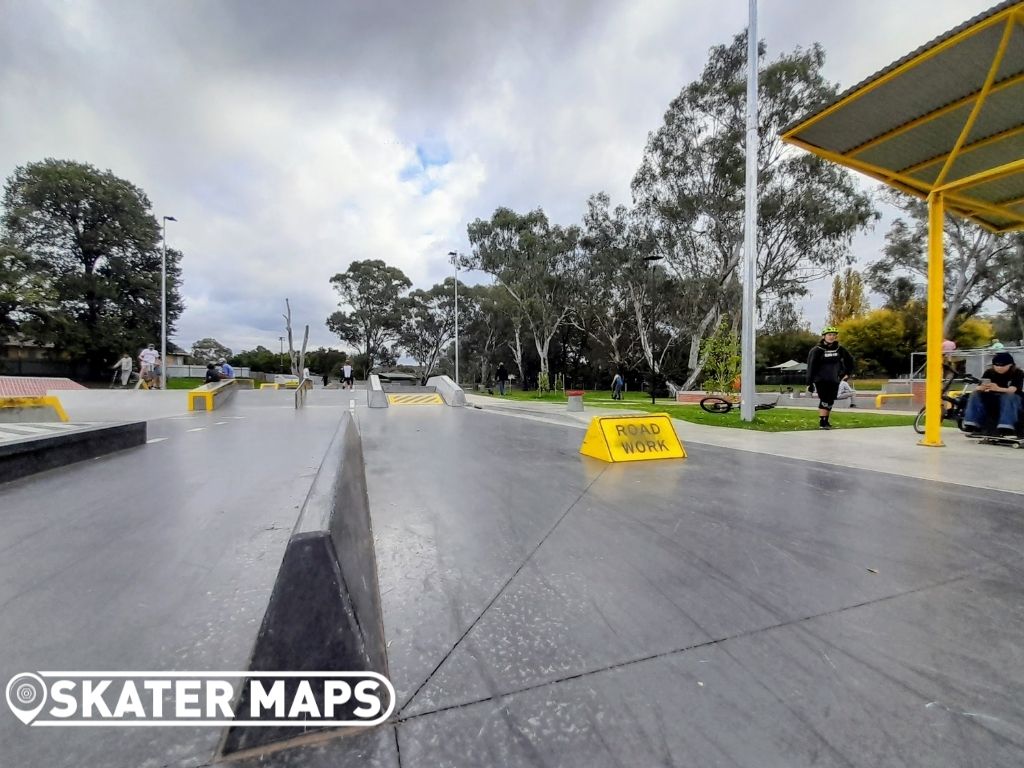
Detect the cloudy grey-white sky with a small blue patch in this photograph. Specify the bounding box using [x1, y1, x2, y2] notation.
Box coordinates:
[0, 0, 995, 350]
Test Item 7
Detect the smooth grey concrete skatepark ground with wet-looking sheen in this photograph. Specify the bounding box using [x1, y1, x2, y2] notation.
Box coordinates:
[0, 389, 1024, 766]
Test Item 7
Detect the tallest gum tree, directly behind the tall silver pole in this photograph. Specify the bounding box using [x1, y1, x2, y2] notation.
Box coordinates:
[633, 32, 877, 388]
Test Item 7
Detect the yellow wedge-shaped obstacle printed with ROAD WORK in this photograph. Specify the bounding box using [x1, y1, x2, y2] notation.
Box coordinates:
[580, 414, 686, 462]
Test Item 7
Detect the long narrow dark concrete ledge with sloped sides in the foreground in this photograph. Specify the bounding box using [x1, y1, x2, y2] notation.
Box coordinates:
[221, 413, 388, 755]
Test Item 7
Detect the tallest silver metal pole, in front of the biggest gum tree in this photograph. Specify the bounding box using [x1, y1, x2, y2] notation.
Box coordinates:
[739, 0, 758, 421]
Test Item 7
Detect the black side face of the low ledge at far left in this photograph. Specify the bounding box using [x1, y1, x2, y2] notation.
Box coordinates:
[0, 421, 146, 482]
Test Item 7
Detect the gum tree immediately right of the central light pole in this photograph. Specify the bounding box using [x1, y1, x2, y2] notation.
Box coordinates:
[464, 208, 580, 374]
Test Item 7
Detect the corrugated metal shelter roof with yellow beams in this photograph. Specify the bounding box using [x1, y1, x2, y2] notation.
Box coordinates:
[782, 0, 1024, 231]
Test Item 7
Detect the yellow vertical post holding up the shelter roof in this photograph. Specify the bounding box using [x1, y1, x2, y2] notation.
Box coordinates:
[918, 193, 945, 447]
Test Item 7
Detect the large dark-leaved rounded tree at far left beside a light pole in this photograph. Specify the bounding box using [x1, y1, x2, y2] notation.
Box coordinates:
[0, 160, 182, 370]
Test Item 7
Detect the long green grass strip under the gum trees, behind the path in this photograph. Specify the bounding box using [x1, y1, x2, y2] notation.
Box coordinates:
[477, 390, 915, 432]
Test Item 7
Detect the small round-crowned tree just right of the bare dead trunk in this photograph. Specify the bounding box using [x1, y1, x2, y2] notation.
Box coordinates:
[327, 259, 413, 378]
